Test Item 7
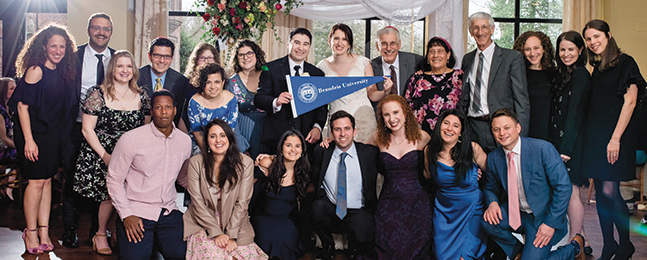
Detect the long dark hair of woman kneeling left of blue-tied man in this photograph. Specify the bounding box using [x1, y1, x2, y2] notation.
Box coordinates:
[264, 130, 310, 196]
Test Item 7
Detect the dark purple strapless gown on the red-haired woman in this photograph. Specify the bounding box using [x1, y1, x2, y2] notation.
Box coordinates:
[375, 150, 431, 260]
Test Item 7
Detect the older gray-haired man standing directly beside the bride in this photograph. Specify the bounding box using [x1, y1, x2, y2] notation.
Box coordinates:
[371, 26, 422, 102]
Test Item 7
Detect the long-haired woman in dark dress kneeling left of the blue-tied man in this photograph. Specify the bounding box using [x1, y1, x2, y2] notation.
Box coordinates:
[252, 130, 310, 260]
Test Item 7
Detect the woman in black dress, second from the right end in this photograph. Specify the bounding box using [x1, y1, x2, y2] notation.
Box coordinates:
[549, 31, 592, 255]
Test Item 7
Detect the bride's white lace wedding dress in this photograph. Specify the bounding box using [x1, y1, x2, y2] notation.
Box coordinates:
[317, 56, 377, 143]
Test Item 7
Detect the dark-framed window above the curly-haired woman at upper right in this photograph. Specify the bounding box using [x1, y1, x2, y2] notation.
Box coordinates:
[467, 0, 564, 51]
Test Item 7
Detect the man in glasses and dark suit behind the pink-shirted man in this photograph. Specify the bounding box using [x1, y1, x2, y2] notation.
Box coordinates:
[137, 37, 190, 127]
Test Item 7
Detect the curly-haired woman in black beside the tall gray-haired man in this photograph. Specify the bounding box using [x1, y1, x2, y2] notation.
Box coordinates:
[514, 31, 555, 140]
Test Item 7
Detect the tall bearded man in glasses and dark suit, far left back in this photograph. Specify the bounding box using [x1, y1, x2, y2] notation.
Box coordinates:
[62, 13, 115, 247]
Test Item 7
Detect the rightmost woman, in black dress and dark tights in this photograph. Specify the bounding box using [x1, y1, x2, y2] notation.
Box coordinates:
[582, 20, 647, 259]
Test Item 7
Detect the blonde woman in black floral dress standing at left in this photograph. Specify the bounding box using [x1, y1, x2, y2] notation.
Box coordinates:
[74, 51, 150, 255]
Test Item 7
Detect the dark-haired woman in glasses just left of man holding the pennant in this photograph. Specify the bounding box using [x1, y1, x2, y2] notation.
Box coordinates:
[227, 40, 265, 158]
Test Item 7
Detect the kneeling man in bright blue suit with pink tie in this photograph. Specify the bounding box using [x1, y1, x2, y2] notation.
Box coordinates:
[483, 108, 585, 260]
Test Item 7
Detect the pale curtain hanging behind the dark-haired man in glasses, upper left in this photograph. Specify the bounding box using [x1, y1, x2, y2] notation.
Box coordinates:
[133, 0, 168, 66]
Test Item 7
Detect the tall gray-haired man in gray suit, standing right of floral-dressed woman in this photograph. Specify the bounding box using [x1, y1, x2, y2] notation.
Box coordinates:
[461, 12, 530, 152]
